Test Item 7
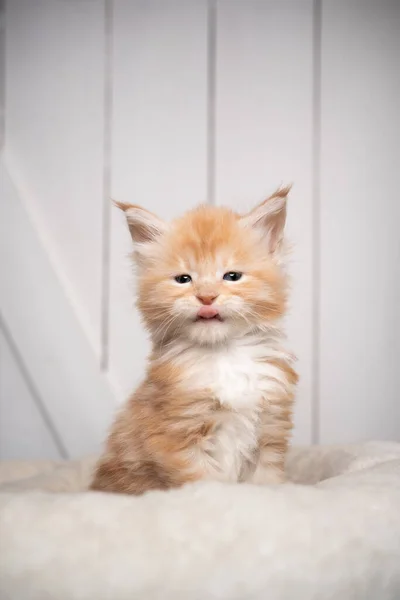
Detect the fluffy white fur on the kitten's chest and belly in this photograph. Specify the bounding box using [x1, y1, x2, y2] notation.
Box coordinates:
[168, 339, 286, 481]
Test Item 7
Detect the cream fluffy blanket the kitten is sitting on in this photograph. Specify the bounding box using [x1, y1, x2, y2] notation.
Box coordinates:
[0, 443, 400, 600]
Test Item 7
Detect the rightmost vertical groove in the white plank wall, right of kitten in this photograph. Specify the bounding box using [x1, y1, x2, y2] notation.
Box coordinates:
[311, 0, 322, 444]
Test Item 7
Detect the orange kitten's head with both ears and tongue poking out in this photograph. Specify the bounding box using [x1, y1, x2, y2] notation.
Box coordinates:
[117, 188, 289, 345]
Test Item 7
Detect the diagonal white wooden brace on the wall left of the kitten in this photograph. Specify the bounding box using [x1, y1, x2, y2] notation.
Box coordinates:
[0, 162, 114, 456]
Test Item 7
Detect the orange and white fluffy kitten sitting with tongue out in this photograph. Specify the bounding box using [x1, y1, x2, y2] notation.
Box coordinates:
[91, 188, 297, 494]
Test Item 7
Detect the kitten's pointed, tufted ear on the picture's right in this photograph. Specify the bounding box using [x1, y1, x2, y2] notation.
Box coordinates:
[241, 186, 292, 254]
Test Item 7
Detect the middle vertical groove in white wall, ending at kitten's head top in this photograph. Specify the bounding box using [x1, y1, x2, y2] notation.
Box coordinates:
[207, 0, 217, 204]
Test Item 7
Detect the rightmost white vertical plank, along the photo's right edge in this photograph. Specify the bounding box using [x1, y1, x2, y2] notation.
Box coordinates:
[320, 0, 400, 442]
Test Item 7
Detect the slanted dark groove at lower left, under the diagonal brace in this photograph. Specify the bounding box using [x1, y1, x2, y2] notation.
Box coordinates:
[0, 314, 69, 460]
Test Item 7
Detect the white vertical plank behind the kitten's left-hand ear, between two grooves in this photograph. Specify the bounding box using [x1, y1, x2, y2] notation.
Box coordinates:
[109, 0, 207, 399]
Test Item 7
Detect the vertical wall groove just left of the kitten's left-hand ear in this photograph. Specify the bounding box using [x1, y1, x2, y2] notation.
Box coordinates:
[100, 0, 113, 371]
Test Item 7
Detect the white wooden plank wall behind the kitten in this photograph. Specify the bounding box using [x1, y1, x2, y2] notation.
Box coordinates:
[0, 0, 400, 458]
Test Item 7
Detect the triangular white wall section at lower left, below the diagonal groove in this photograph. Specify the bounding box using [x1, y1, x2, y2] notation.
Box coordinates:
[0, 329, 63, 460]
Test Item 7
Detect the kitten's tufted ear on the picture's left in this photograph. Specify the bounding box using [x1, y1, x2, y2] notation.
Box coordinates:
[114, 201, 167, 249]
